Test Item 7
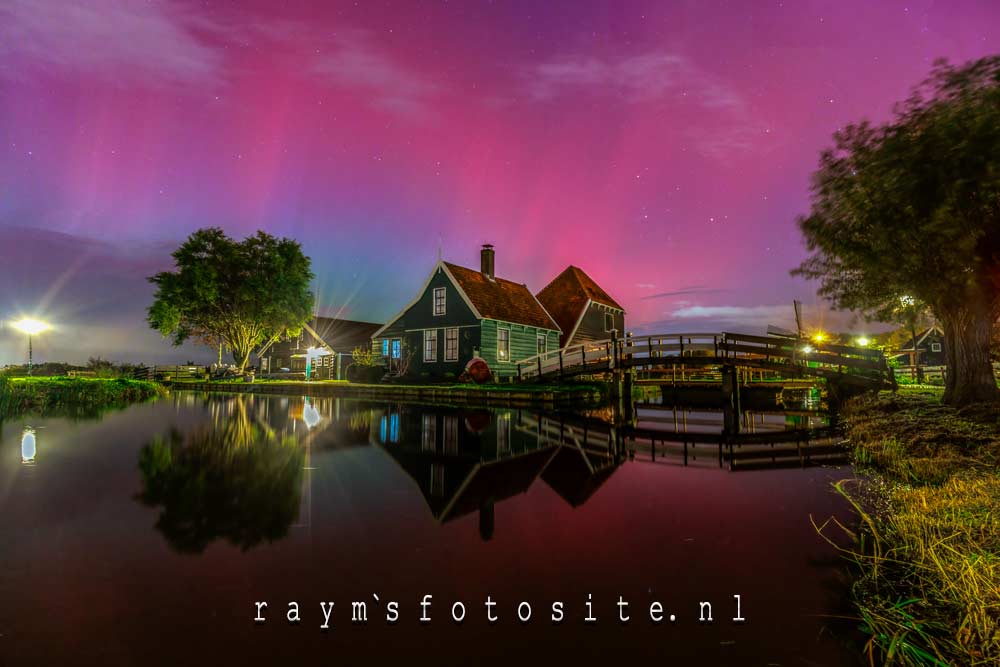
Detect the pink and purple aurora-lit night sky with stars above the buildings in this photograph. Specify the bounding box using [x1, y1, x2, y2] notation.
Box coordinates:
[0, 0, 1000, 364]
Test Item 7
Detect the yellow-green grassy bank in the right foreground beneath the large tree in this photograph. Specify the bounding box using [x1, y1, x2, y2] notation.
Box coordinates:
[838, 388, 1000, 665]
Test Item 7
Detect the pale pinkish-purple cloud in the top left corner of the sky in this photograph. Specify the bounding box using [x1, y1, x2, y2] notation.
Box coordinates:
[0, 0, 223, 87]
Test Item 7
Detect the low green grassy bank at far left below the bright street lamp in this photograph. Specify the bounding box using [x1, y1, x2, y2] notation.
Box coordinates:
[0, 376, 163, 417]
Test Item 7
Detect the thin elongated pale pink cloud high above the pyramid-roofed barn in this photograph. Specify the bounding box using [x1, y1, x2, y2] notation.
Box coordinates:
[525, 51, 743, 109]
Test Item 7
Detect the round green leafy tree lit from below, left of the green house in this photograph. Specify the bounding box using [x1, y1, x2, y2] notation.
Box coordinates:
[148, 228, 313, 372]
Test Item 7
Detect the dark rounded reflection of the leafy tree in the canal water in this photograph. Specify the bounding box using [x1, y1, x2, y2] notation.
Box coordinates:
[139, 396, 305, 554]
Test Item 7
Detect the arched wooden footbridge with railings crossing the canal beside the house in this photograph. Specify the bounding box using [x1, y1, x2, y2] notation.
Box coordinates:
[517, 333, 895, 389]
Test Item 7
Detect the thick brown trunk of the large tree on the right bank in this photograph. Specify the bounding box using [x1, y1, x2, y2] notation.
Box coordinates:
[940, 302, 1000, 407]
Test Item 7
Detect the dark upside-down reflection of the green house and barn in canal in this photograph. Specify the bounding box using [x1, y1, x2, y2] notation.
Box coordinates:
[371, 406, 619, 541]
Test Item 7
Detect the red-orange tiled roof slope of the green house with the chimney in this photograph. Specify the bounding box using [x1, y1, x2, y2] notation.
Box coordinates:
[443, 262, 559, 330]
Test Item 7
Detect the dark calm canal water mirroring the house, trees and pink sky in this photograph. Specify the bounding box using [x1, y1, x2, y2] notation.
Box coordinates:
[0, 392, 858, 665]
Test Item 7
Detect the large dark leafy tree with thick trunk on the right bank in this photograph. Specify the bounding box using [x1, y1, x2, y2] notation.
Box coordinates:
[793, 56, 1000, 405]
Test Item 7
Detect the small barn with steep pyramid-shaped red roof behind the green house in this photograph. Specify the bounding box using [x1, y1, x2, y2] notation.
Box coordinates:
[538, 265, 625, 347]
